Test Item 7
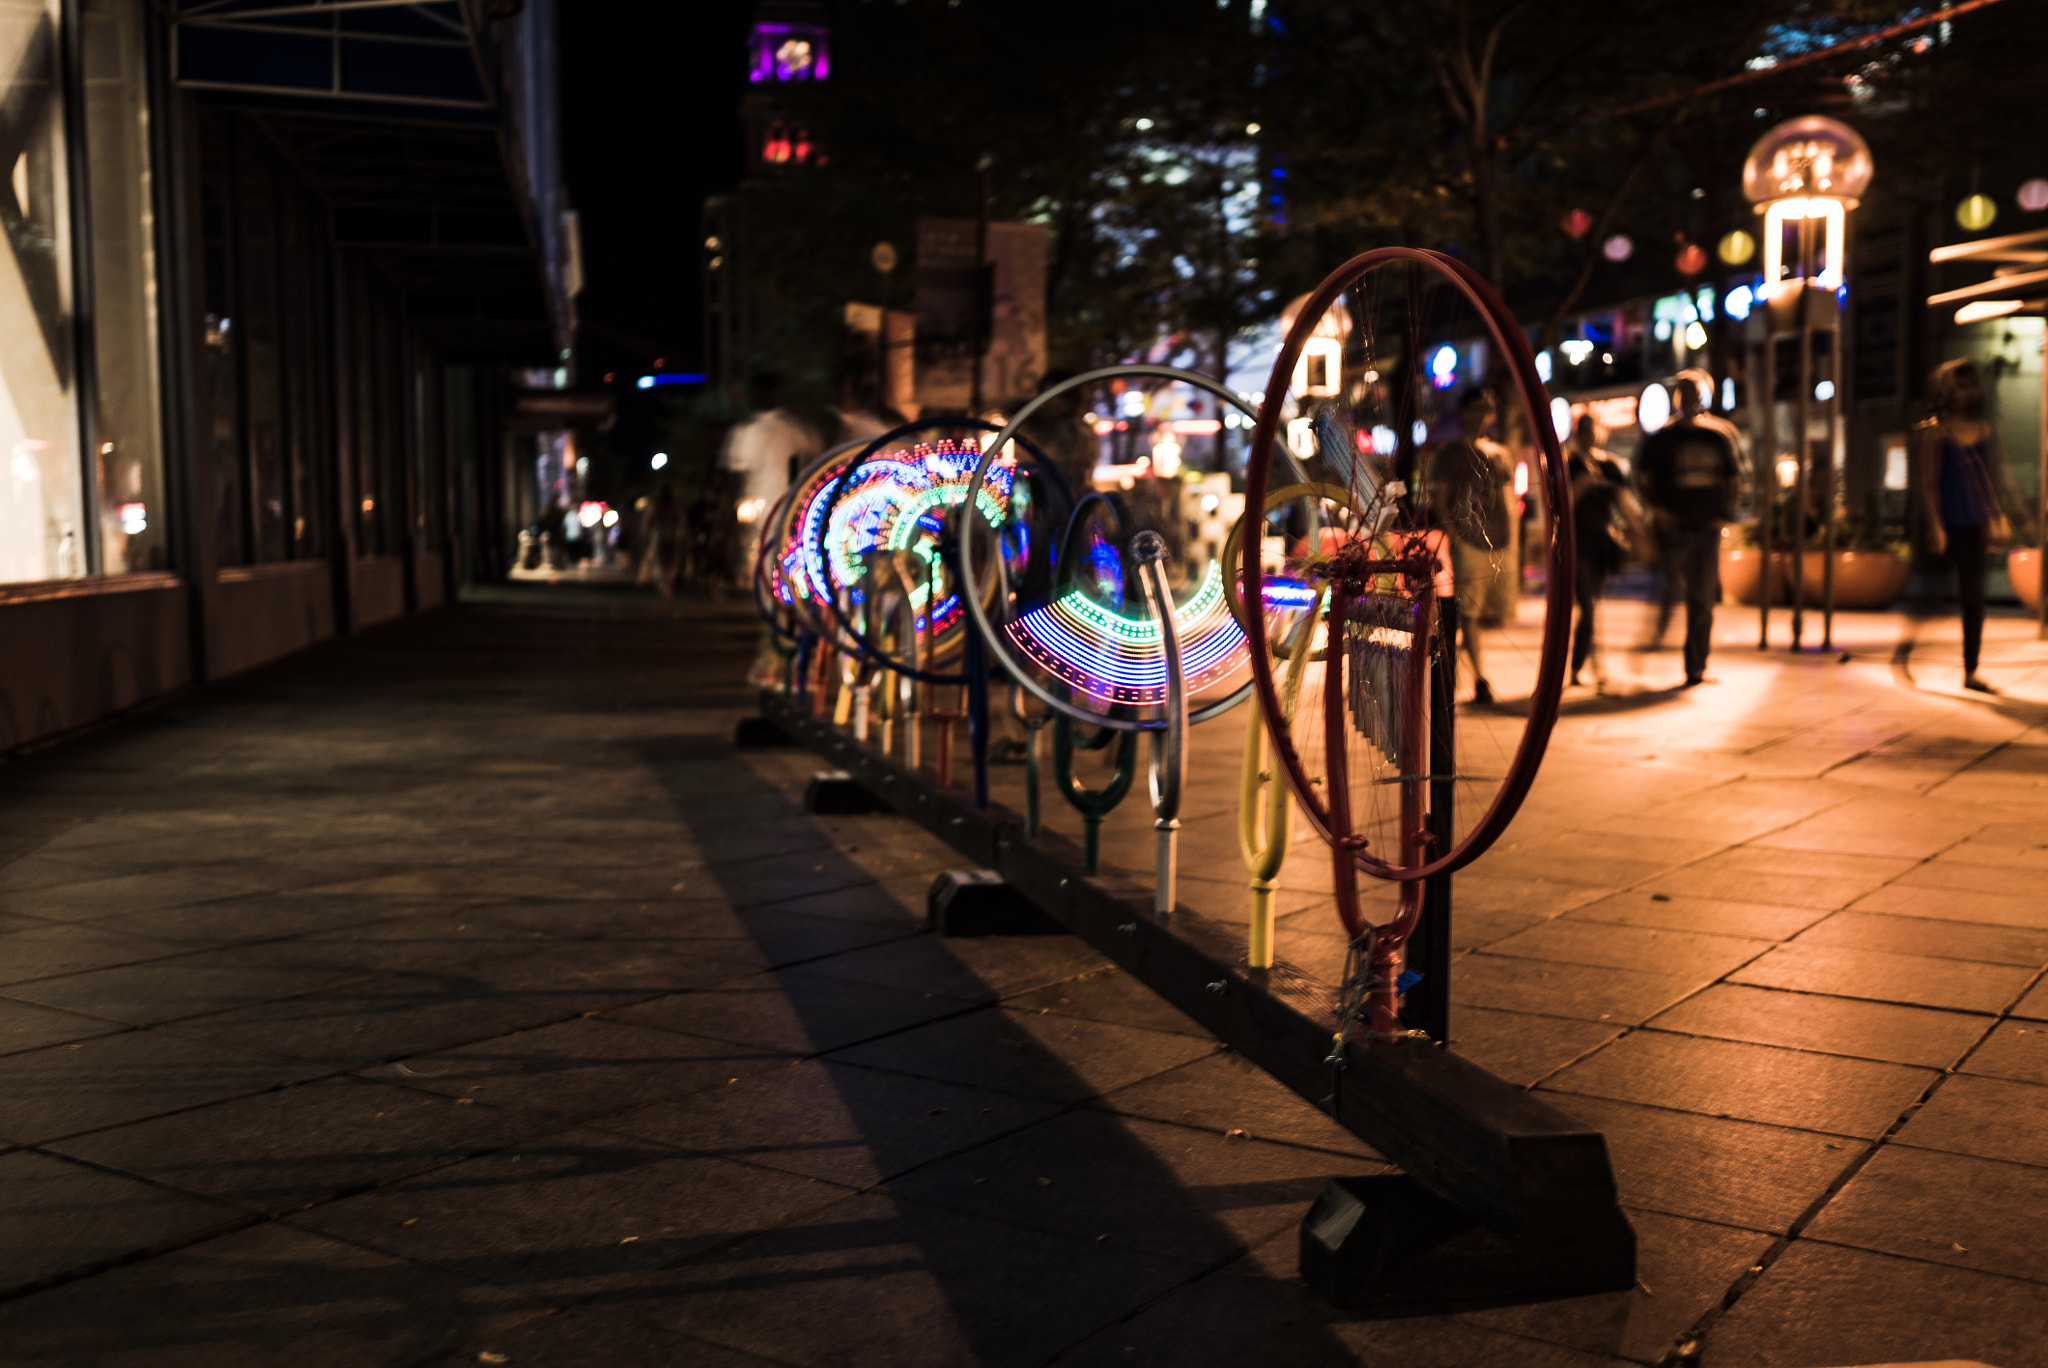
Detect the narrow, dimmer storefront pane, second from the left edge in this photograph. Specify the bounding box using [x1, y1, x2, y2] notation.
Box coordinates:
[84, 0, 168, 575]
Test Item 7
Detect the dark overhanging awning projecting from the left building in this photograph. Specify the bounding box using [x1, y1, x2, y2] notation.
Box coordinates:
[172, 0, 573, 365]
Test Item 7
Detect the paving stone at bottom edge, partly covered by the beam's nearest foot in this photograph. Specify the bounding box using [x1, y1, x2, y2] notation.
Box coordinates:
[1460, 1212, 1772, 1362]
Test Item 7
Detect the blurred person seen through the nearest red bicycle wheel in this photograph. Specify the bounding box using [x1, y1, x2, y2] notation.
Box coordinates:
[1430, 387, 1522, 707]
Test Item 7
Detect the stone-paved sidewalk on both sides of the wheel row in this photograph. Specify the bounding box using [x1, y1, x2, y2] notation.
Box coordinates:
[0, 592, 2048, 1368]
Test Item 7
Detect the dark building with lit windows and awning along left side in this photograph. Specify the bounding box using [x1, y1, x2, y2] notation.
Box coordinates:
[0, 0, 578, 747]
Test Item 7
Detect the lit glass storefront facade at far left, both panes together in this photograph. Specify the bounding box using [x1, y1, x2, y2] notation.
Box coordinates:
[0, 0, 168, 584]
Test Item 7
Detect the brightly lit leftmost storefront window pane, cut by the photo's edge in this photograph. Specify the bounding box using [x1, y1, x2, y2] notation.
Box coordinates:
[0, 0, 88, 582]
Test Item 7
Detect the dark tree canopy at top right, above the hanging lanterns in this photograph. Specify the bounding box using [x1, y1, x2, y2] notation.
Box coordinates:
[1270, 0, 2007, 342]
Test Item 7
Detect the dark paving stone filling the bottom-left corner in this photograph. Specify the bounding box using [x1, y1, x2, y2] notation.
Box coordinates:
[0, 1225, 532, 1368]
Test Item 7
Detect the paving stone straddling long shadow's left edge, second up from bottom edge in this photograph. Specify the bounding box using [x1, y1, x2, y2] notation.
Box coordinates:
[602, 1059, 1059, 1188]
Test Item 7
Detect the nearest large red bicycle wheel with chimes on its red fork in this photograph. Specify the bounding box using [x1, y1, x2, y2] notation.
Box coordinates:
[1241, 248, 1571, 1036]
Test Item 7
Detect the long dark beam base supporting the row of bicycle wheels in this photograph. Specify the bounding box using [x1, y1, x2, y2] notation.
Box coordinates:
[762, 692, 1636, 1309]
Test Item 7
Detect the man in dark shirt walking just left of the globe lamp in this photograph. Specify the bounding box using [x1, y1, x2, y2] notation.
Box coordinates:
[1636, 385, 1743, 688]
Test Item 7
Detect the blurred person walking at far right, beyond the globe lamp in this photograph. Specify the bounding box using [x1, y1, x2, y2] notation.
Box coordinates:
[1892, 358, 2019, 694]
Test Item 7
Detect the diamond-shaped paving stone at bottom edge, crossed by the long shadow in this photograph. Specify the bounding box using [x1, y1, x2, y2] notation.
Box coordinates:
[629, 1194, 1194, 1368]
